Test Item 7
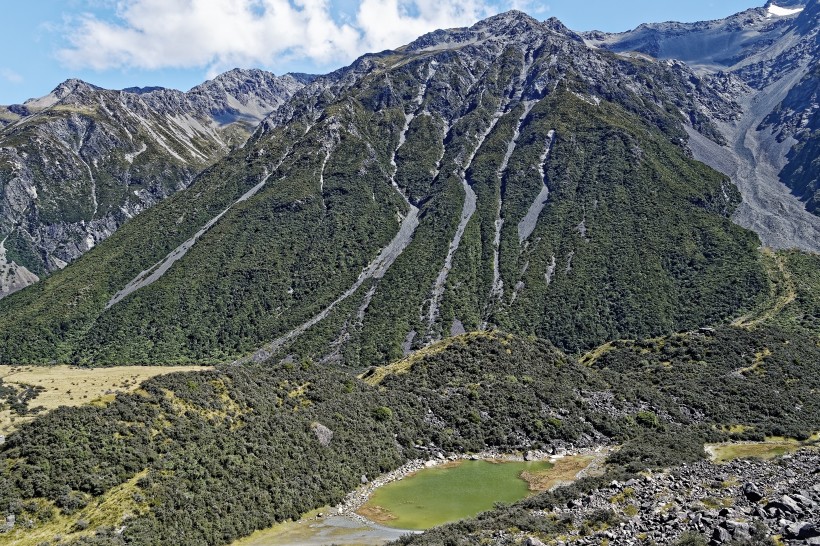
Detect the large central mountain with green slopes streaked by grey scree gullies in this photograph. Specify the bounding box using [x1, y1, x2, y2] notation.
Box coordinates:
[0, 12, 766, 366]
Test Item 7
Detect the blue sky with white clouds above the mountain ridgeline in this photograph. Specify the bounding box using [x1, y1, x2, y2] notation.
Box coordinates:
[0, 0, 764, 104]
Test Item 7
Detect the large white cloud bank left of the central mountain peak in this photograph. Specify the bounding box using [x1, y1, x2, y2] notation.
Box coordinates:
[58, 0, 500, 72]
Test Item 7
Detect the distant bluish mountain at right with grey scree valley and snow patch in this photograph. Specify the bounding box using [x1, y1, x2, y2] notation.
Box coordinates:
[584, 0, 820, 252]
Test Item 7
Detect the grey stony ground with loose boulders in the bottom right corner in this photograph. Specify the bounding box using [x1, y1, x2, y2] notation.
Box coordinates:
[523, 449, 820, 546]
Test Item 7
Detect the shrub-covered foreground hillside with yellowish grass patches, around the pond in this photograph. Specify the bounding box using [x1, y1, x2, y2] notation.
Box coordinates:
[0, 248, 820, 544]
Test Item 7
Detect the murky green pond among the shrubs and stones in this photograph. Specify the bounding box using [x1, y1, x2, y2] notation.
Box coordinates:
[359, 461, 552, 530]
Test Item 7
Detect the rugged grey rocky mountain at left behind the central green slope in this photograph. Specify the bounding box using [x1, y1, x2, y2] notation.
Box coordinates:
[0, 69, 310, 297]
